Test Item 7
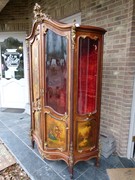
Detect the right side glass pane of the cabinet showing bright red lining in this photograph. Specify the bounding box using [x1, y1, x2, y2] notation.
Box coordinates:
[77, 37, 98, 114]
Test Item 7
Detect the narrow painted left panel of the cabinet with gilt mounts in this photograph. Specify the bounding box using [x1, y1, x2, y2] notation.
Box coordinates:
[31, 34, 41, 144]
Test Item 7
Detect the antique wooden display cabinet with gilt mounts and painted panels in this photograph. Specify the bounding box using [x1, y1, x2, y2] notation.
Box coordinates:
[27, 4, 106, 174]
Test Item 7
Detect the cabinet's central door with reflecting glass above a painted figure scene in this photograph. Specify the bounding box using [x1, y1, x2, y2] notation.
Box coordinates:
[43, 28, 69, 154]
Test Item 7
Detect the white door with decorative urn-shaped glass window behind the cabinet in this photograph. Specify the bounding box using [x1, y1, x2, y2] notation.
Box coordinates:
[0, 33, 28, 108]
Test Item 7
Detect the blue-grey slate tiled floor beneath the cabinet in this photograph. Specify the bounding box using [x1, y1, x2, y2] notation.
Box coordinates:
[0, 111, 135, 180]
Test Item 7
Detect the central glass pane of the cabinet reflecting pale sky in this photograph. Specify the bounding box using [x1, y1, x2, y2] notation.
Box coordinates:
[45, 30, 67, 114]
